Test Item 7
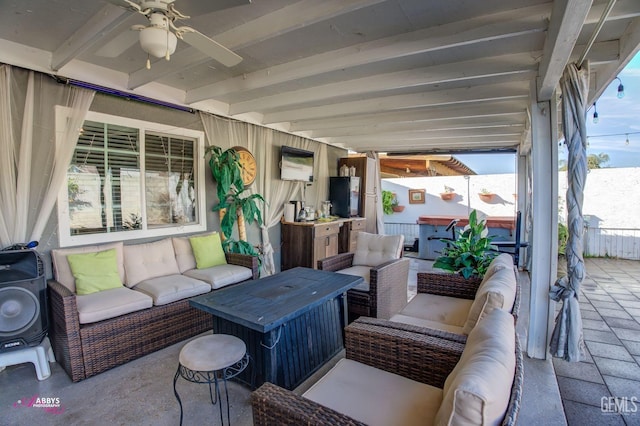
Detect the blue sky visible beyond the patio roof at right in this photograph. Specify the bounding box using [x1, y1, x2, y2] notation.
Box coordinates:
[455, 53, 640, 174]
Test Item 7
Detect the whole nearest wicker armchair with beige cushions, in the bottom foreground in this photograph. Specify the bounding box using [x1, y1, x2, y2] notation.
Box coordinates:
[251, 310, 523, 426]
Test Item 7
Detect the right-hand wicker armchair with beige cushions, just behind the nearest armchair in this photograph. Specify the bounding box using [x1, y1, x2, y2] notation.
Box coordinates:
[384, 253, 520, 342]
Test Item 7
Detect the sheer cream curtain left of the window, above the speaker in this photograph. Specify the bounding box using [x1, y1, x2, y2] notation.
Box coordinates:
[0, 65, 95, 247]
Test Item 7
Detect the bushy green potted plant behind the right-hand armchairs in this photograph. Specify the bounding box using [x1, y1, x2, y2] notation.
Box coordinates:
[433, 210, 497, 278]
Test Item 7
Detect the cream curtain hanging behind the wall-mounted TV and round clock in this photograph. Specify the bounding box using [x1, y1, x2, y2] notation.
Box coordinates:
[200, 113, 329, 276]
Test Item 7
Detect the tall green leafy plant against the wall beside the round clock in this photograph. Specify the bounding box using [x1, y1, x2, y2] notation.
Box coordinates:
[205, 146, 264, 257]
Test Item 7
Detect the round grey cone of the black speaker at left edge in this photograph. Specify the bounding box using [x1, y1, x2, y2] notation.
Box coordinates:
[0, 287, 40, 337]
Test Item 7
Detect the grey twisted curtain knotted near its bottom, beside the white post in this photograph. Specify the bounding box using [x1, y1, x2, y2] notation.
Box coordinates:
[550, 64, 589, 362]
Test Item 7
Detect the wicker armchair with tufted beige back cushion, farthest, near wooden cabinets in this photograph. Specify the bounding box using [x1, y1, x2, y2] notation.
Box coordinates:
[318, 232, 410, 322]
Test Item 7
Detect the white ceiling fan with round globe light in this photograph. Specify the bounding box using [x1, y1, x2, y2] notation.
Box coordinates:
[108, 0, 242, 69]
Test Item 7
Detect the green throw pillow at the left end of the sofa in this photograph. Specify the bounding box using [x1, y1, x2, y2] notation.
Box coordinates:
[67, 249, 122, 295]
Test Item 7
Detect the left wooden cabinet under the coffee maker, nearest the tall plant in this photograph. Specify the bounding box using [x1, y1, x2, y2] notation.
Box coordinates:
[281, 221, 344, 271]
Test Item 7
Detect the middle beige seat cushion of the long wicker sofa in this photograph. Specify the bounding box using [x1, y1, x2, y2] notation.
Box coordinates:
[134, 274, 211, 306]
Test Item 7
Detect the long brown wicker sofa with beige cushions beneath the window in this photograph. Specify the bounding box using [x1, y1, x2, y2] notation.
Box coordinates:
[48, 237, 258, 382]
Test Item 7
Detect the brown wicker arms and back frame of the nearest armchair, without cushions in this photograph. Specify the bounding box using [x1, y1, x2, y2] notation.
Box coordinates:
[251, 310, 524, 426]
